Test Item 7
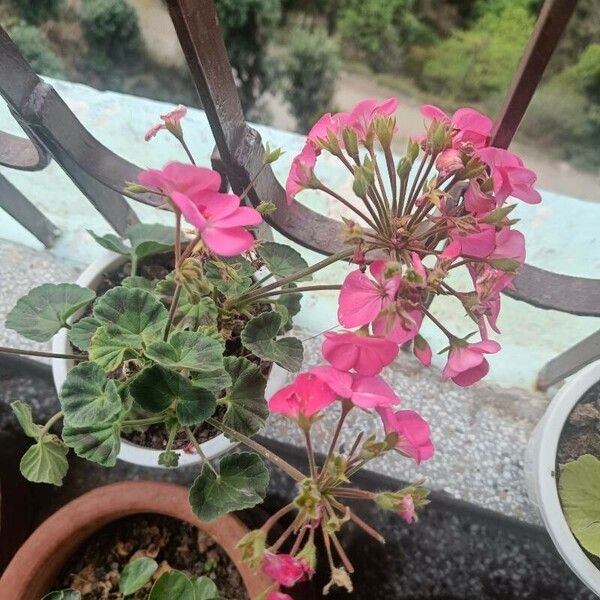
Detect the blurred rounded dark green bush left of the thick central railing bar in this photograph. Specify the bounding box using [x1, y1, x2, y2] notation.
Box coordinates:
[81, 0, 143, 70]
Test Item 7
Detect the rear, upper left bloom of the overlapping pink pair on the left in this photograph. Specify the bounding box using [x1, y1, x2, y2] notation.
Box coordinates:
[138, 162, 221, 196]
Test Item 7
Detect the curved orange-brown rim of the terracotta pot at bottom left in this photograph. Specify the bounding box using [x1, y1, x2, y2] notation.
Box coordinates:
[0, 481, 273, 600]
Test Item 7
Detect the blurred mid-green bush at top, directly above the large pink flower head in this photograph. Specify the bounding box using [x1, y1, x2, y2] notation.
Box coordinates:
[338, 0, 436, 73]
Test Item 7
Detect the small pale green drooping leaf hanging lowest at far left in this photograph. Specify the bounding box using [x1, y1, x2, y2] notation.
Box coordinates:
[19, 434, 69, 486]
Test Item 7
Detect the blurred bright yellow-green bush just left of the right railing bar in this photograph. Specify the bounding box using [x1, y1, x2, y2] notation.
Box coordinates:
[421, 3, 534, 101]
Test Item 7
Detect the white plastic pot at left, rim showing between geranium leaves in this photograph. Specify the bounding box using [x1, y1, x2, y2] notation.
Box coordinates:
[52, 251, 287, 468]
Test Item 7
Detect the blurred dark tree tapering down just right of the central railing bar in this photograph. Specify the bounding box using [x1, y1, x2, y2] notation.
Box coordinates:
[216, 0, 281, 113]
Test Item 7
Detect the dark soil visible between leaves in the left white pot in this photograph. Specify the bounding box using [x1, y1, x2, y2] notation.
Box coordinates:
[82, 253, 271, 452]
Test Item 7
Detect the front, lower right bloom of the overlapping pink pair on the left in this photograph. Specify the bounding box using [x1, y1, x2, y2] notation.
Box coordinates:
[171, 192, 262, 256]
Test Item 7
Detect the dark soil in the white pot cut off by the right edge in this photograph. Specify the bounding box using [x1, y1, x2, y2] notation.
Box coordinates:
[555, 382, 600, 569]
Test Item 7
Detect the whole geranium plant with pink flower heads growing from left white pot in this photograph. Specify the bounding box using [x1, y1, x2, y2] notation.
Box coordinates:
[2, 99, 540, 600]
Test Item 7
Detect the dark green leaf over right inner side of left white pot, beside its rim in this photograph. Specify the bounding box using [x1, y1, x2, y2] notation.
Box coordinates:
[219, 356, 269, 436]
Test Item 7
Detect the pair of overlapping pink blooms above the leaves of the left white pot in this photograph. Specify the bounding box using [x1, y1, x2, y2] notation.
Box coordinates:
[138, 162, 262, 256]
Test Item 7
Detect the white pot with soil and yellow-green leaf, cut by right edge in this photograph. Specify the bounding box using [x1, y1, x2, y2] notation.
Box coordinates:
[526, 362, 600, 594]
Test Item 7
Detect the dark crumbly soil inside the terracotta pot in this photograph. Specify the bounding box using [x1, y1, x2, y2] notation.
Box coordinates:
[53, 514, 249, 600]
